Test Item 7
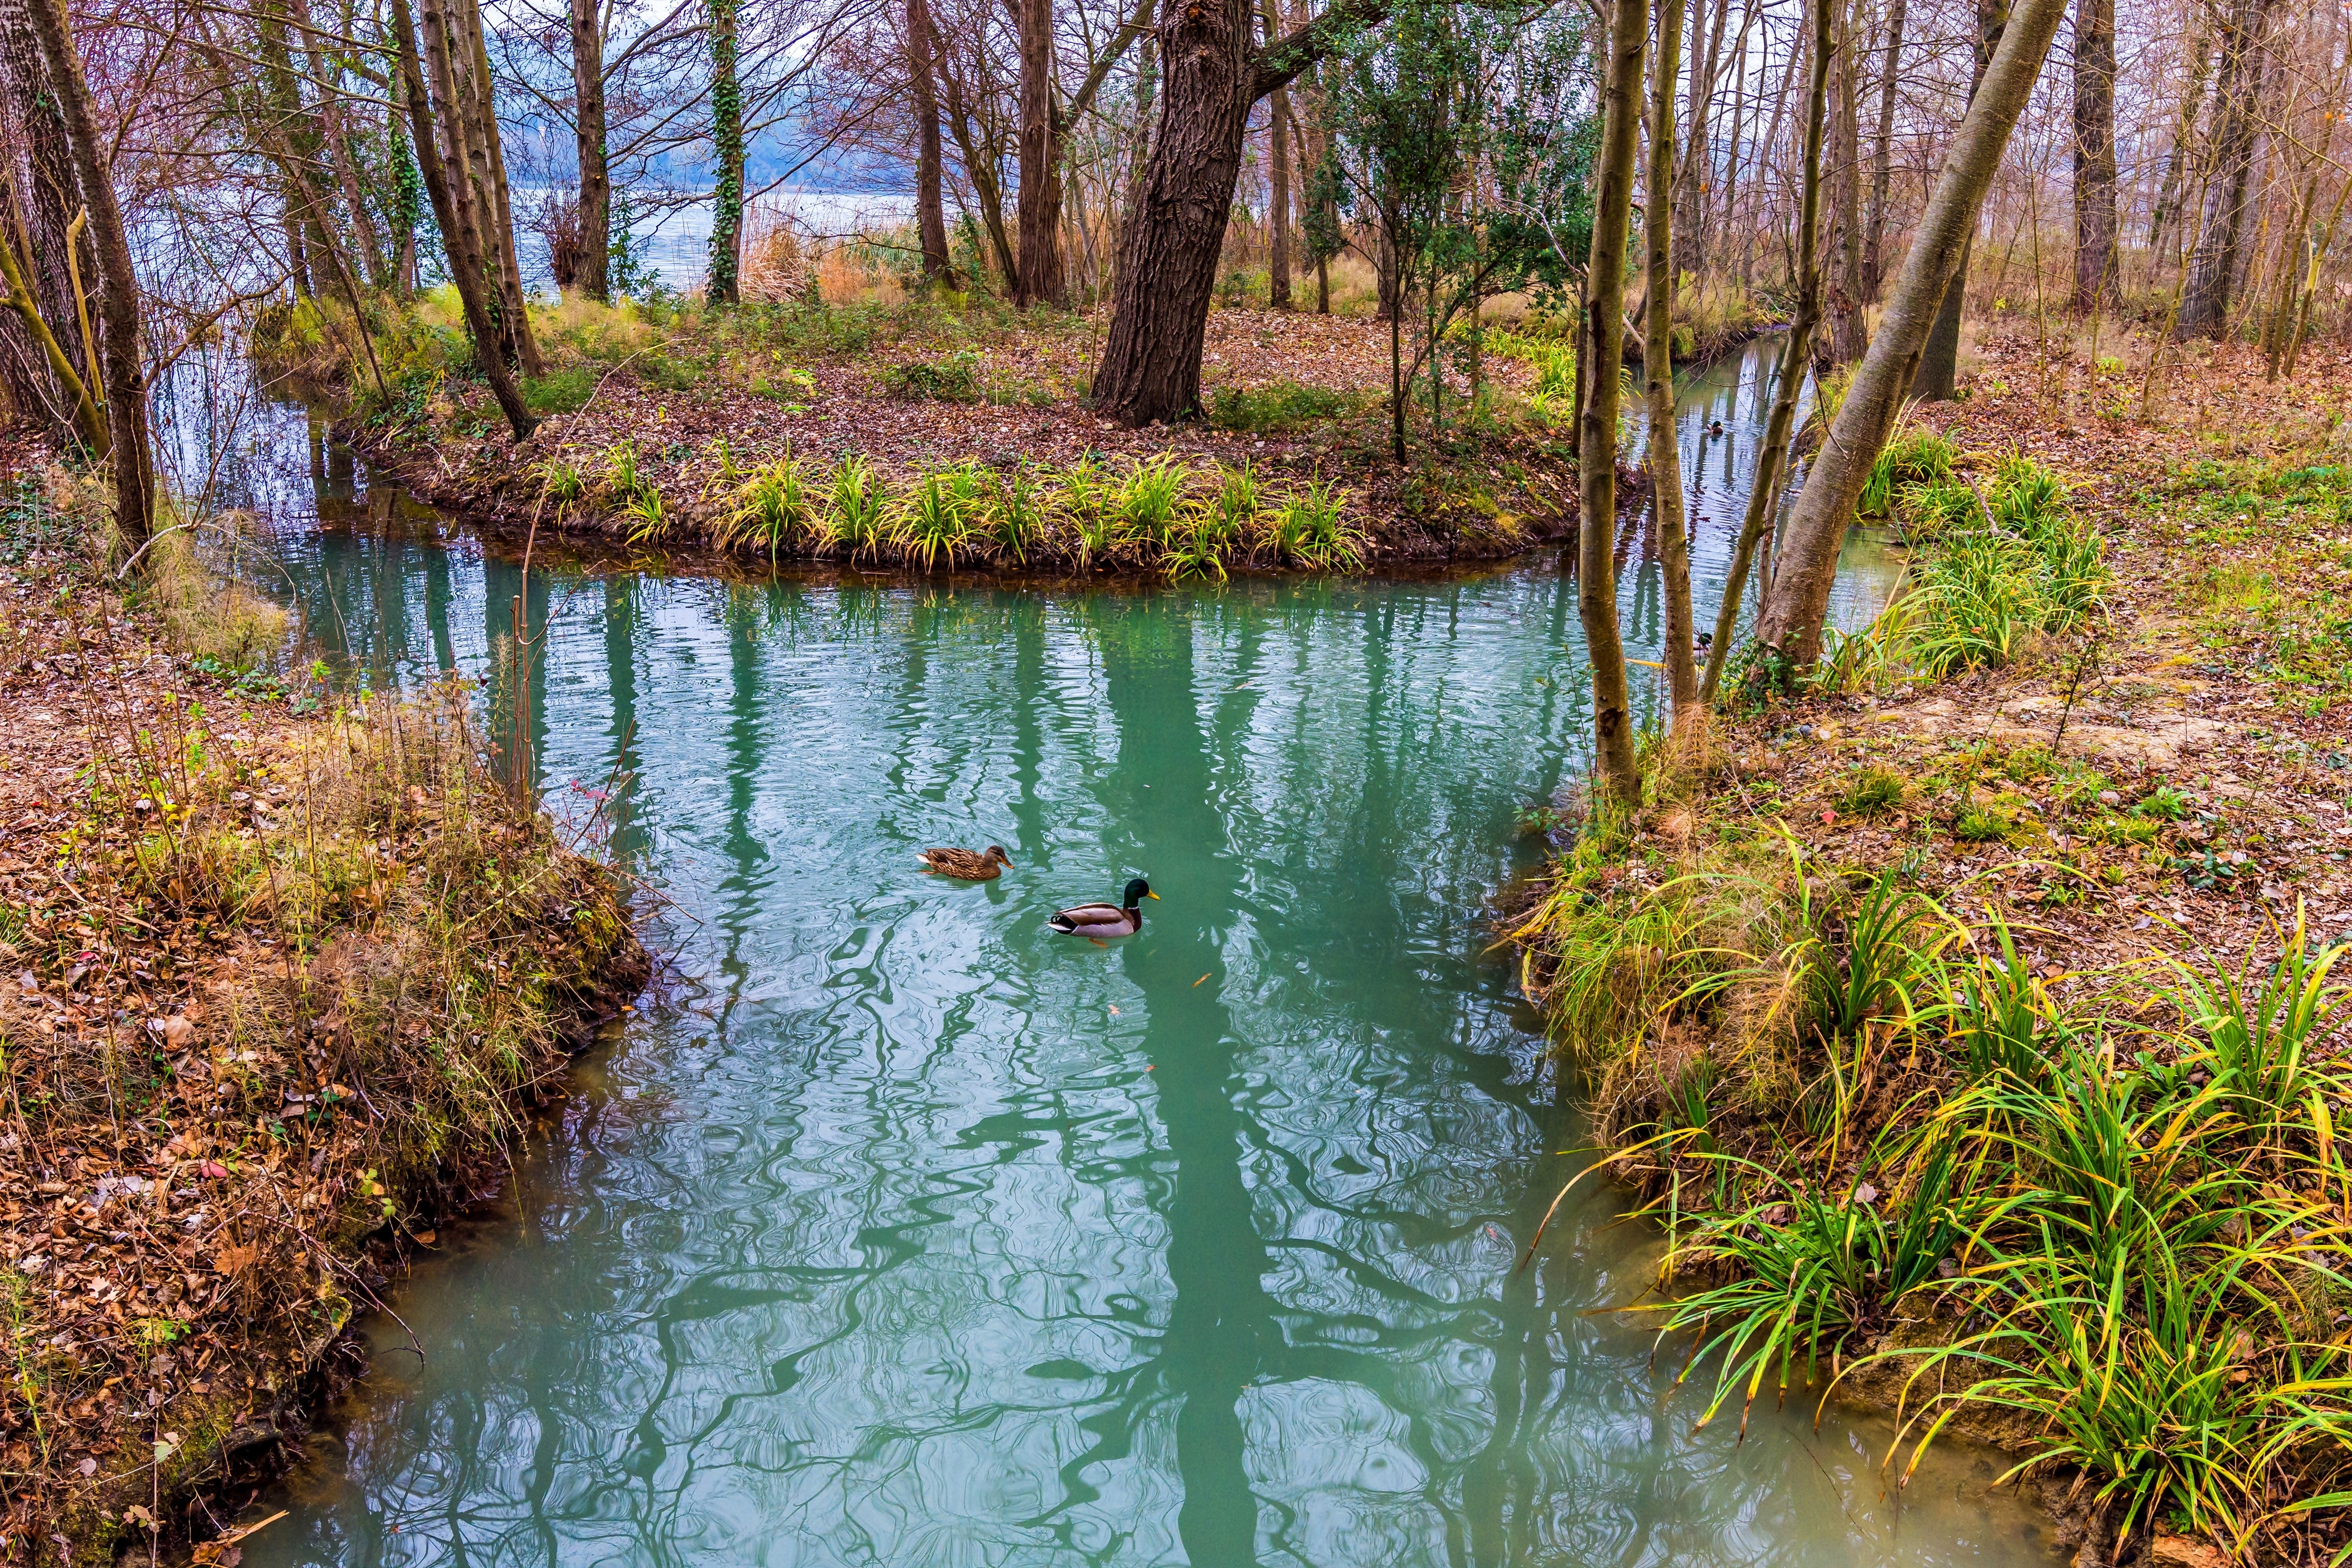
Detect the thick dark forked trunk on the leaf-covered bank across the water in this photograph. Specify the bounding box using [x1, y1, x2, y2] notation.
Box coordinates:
[1094, 0, 1383, 426]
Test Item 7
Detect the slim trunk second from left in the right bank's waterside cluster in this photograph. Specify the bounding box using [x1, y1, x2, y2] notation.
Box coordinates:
[1642, 0, 1693, 731]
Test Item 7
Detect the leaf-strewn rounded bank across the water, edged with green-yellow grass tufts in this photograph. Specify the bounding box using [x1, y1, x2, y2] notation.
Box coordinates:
[263, 298, 1642, 576]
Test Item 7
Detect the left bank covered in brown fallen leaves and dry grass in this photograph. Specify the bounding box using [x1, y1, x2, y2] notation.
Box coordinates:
[0, 447, 647, 1563]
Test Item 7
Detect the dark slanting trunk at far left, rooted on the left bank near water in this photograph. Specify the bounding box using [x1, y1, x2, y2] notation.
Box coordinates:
[28, 0, 155, 550]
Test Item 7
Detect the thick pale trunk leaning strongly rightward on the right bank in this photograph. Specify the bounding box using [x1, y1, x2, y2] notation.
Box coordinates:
[1757, 0, 2065, 672]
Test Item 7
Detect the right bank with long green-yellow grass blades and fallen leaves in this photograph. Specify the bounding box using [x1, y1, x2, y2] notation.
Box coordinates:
[1515, 336, 2352, 1563]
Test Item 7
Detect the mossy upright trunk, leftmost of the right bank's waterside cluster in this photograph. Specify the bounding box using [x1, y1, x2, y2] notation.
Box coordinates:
[1576, 0, 1649, 811]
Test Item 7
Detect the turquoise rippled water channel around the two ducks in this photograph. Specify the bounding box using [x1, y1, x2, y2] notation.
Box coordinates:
[165, 355, 2056, 1568]
